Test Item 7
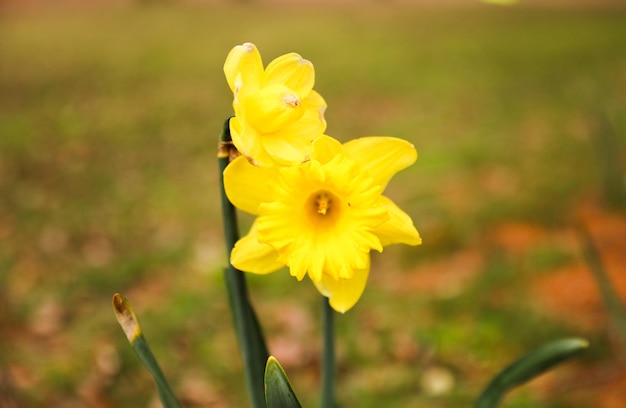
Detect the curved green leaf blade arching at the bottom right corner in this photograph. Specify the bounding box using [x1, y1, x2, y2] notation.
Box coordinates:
[475, 338, 589, 408]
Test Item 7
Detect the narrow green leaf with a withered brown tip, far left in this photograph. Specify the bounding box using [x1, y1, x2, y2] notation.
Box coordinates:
[113, 293, 180, 408]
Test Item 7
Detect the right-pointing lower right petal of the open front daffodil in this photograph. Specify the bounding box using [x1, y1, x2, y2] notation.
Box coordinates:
[374, 196, 422, 246]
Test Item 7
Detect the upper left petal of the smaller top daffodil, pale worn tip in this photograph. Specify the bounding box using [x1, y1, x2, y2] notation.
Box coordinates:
[224, 43, 263, 92]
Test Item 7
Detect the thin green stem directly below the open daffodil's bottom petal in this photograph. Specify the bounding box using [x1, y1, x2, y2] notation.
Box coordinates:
[321, 296, 337, 408]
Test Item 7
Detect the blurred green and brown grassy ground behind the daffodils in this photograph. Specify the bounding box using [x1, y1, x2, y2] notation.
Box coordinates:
[0, 0, 626, 408]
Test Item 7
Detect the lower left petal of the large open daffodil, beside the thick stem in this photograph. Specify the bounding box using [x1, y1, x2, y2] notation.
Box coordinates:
[230, 221, 284, 274]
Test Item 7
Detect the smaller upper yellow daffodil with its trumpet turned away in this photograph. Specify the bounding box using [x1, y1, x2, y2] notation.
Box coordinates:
[224, 43, 326, 165]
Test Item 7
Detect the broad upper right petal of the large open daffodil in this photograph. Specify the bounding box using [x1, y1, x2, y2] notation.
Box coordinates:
[343, 136, 417, 190]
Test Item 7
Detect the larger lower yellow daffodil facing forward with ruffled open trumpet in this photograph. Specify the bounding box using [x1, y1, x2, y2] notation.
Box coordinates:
[224, 136, 421, 313]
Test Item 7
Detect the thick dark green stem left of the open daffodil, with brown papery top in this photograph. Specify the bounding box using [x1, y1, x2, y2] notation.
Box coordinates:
[217, 118, 269, 408]
